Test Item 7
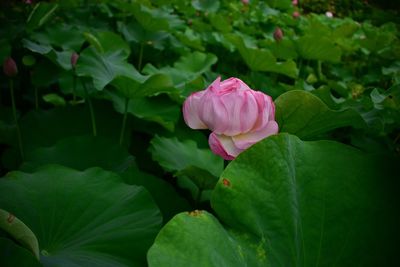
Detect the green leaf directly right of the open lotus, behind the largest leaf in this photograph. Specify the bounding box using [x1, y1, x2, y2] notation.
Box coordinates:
[275, 90, 365, 139]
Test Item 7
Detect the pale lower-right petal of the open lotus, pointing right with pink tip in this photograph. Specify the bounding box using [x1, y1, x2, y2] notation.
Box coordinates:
[232, 121, 279, 150]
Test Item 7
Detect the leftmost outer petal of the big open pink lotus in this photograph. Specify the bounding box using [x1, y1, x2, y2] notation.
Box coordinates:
[182, 91, 208, 129]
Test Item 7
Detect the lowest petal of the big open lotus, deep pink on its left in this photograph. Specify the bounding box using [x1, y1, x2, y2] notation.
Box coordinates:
[208, 132, 242, 160]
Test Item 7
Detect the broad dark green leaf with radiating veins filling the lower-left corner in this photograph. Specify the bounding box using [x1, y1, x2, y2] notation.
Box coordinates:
[0, 165, 161, 267]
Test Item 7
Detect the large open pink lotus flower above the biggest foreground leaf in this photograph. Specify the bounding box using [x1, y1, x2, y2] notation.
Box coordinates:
[183, 77, 278, 160]
